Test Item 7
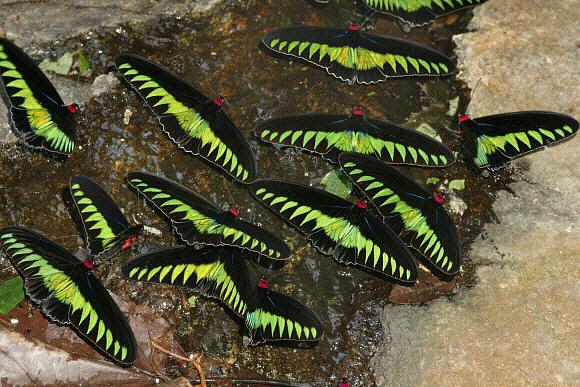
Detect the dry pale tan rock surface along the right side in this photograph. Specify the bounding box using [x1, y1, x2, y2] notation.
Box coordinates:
[373, 0, 580, 386]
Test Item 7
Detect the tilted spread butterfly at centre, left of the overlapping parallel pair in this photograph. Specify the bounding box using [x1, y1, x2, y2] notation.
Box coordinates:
[250, 179, 418, 285]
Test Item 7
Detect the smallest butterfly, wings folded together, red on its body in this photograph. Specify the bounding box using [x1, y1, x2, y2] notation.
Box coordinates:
[69, 175, 143, 264]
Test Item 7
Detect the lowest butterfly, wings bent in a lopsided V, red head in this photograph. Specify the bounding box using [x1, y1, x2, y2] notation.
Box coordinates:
[122, 246, 324, 345]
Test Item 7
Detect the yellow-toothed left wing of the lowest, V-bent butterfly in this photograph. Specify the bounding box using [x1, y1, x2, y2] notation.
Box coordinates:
[121, 246, 253, 317]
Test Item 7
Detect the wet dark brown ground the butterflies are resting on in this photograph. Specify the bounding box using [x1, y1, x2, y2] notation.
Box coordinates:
[0, 0, 511, 386]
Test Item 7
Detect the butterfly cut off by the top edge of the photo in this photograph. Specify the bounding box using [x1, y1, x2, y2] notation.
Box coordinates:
[363, 0, 487, 27]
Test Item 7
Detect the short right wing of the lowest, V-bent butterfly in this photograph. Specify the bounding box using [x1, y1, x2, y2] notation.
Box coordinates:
[246, 288, 324, 345]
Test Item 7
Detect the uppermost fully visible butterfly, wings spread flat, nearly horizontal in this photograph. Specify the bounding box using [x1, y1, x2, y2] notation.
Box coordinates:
[263, 24, 455, 84]
